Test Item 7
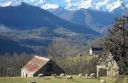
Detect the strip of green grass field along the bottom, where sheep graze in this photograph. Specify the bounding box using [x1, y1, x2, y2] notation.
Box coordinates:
[0, 76, 128, 83]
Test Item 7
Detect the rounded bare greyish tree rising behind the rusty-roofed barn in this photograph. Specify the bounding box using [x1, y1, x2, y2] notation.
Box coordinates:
[48, 40, 72, 57]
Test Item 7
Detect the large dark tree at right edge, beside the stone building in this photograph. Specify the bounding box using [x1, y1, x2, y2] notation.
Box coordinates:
[104, 16, 128, 74]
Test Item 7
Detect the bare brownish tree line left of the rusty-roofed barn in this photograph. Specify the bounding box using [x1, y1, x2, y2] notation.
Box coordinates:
[0, 53, 32, 77]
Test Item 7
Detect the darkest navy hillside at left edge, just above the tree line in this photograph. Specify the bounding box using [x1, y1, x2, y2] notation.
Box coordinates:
[0, 36, 33, 54]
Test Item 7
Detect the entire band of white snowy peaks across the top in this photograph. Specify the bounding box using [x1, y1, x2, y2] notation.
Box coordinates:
[0, 0, 128, 12]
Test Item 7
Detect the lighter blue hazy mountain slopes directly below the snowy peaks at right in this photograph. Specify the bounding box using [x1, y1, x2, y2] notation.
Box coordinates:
[48, 7, 125, 34]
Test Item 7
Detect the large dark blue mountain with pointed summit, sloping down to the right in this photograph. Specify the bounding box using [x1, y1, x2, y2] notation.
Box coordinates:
[0, 3, 98, 34]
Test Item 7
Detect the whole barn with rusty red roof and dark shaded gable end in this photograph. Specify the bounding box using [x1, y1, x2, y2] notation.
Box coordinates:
[21, 56, 64, 77]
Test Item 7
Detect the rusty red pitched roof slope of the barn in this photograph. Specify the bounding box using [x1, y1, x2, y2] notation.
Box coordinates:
[23, 56, 50, 73]
